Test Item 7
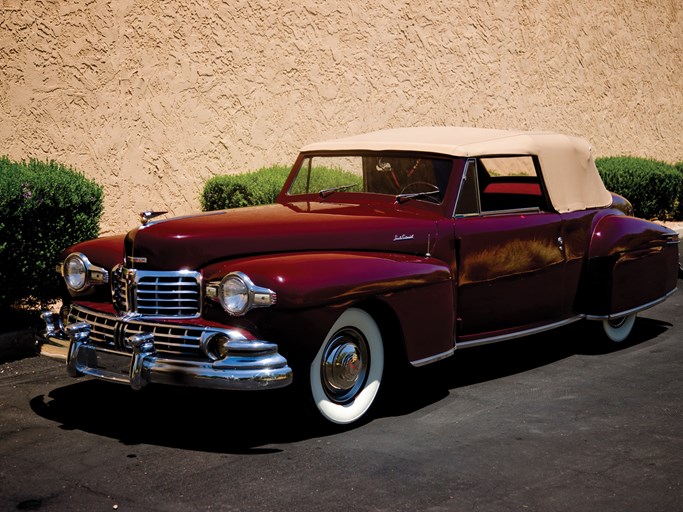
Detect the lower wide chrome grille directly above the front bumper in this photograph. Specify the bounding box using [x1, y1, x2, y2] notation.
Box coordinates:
[69, 305, 207, 359]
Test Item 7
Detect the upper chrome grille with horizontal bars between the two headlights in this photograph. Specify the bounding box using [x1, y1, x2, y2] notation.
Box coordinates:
[111, 266, 201, 318]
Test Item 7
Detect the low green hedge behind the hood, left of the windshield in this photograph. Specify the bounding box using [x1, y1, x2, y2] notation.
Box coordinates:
[200, 166, 290, 212]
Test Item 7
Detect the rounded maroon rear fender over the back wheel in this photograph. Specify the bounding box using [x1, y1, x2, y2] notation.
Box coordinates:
[579, 215, 679, 317]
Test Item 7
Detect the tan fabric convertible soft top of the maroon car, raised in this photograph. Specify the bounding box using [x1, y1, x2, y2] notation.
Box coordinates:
[302, 126, 612, 212]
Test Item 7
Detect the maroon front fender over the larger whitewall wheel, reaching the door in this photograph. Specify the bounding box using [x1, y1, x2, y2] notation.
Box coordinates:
[204, 252, 455, 366]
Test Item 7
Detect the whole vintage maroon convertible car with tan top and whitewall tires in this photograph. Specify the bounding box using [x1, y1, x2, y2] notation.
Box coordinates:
[37, 127, 679, 424]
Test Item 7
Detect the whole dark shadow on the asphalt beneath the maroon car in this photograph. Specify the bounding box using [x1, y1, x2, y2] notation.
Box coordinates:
[30, 319, 668, 454]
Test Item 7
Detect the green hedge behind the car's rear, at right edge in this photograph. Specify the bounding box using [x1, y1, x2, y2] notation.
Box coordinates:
[595, 157, 683, 220]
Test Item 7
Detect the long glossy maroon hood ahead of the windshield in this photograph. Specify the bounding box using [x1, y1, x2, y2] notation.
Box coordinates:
[125, 203, 436, 270]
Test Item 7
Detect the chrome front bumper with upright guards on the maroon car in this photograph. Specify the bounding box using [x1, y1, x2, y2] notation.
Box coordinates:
[36, 312, 292, 390]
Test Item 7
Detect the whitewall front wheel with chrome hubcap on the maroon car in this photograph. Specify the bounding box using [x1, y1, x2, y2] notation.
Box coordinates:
[310, 308, 384, 425]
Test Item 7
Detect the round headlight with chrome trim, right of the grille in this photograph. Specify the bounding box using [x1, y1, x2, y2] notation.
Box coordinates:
[207, 271, 277, 316]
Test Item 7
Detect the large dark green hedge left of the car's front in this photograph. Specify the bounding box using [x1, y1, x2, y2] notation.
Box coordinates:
[0, 157, 103, 308]
